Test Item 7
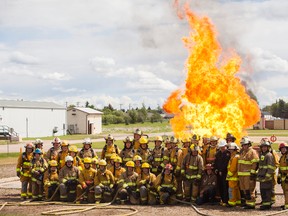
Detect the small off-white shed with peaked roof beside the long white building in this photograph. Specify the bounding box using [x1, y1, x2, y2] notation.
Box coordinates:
[67, 107, 103, 134]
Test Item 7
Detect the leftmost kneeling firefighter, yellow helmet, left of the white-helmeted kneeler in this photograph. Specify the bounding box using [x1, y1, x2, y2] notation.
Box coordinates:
[43, 160, 59, 200]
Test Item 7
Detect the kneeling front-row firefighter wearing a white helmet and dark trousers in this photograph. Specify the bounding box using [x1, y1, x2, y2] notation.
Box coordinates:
[59, 155, 80, 202]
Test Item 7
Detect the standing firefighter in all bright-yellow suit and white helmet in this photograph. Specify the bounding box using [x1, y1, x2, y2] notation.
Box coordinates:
[226, 142, 241, 207]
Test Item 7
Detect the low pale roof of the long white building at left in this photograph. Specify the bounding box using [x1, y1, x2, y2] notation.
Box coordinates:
[0, 100, 66, 109]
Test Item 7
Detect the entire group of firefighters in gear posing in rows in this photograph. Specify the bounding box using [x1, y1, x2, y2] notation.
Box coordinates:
[16, 129, 288, 210]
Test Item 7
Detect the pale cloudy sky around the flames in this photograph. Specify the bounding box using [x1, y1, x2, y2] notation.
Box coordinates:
[0, 0, 288, 109]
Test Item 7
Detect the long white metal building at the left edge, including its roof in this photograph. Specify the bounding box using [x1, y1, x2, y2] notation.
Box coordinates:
[0, 100, 66, 137]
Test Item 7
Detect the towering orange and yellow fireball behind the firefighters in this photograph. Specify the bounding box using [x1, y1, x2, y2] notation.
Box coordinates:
[163, 5, 260, 140]
